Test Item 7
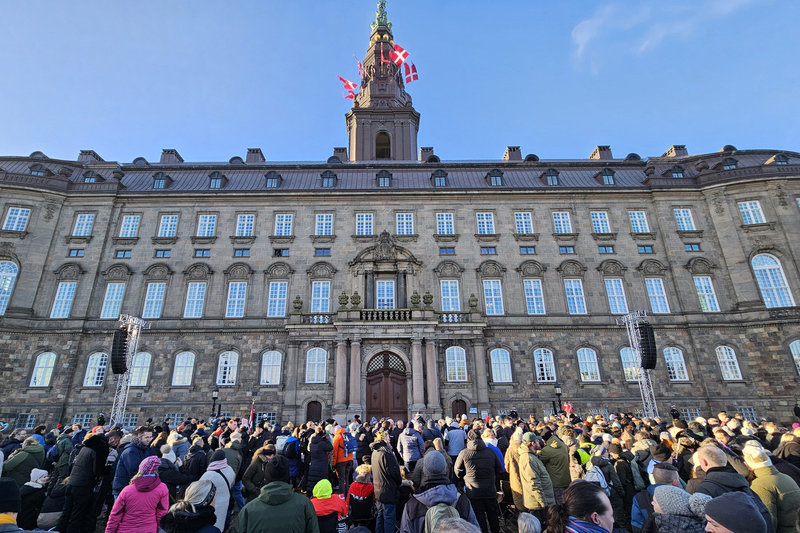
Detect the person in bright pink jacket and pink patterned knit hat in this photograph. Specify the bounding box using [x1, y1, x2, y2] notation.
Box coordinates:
[106, 456, 169, 533]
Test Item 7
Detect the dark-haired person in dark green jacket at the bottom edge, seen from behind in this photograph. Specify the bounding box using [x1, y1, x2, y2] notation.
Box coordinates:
[231, 455, 319, 533]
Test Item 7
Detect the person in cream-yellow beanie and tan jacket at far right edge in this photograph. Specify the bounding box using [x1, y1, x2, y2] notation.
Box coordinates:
[744, 446, 800, 533]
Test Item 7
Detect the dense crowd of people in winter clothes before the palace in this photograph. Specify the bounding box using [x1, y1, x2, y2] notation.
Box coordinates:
[0, 410, 800, 533]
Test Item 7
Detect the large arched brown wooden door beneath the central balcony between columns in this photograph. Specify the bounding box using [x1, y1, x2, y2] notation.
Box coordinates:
[367, 352, 408, 420]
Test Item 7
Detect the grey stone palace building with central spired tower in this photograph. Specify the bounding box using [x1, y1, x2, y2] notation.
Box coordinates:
[0, 7, 800, 427]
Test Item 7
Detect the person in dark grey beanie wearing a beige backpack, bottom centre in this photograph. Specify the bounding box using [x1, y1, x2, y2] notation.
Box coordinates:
[400, 452, 478, 533]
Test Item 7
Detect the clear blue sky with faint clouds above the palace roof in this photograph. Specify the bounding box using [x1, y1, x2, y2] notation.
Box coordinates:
[0, 0, 800, 162]
